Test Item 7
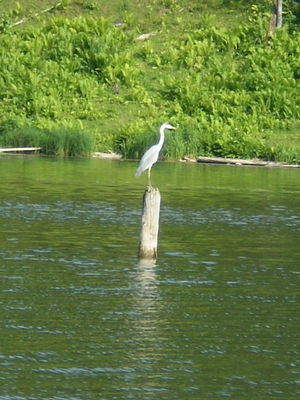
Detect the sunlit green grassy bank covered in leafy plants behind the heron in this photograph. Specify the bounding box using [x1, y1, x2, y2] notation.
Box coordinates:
[0, 0, 300, 163]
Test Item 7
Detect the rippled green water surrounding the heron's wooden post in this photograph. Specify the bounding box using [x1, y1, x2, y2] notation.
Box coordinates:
[0, 156, 300, 400]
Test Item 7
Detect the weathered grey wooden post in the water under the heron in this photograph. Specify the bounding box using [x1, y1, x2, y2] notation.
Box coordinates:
[139, 186, 160, 260]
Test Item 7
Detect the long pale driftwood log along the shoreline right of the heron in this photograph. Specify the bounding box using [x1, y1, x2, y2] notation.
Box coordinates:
[183, 156, 300, 168]
